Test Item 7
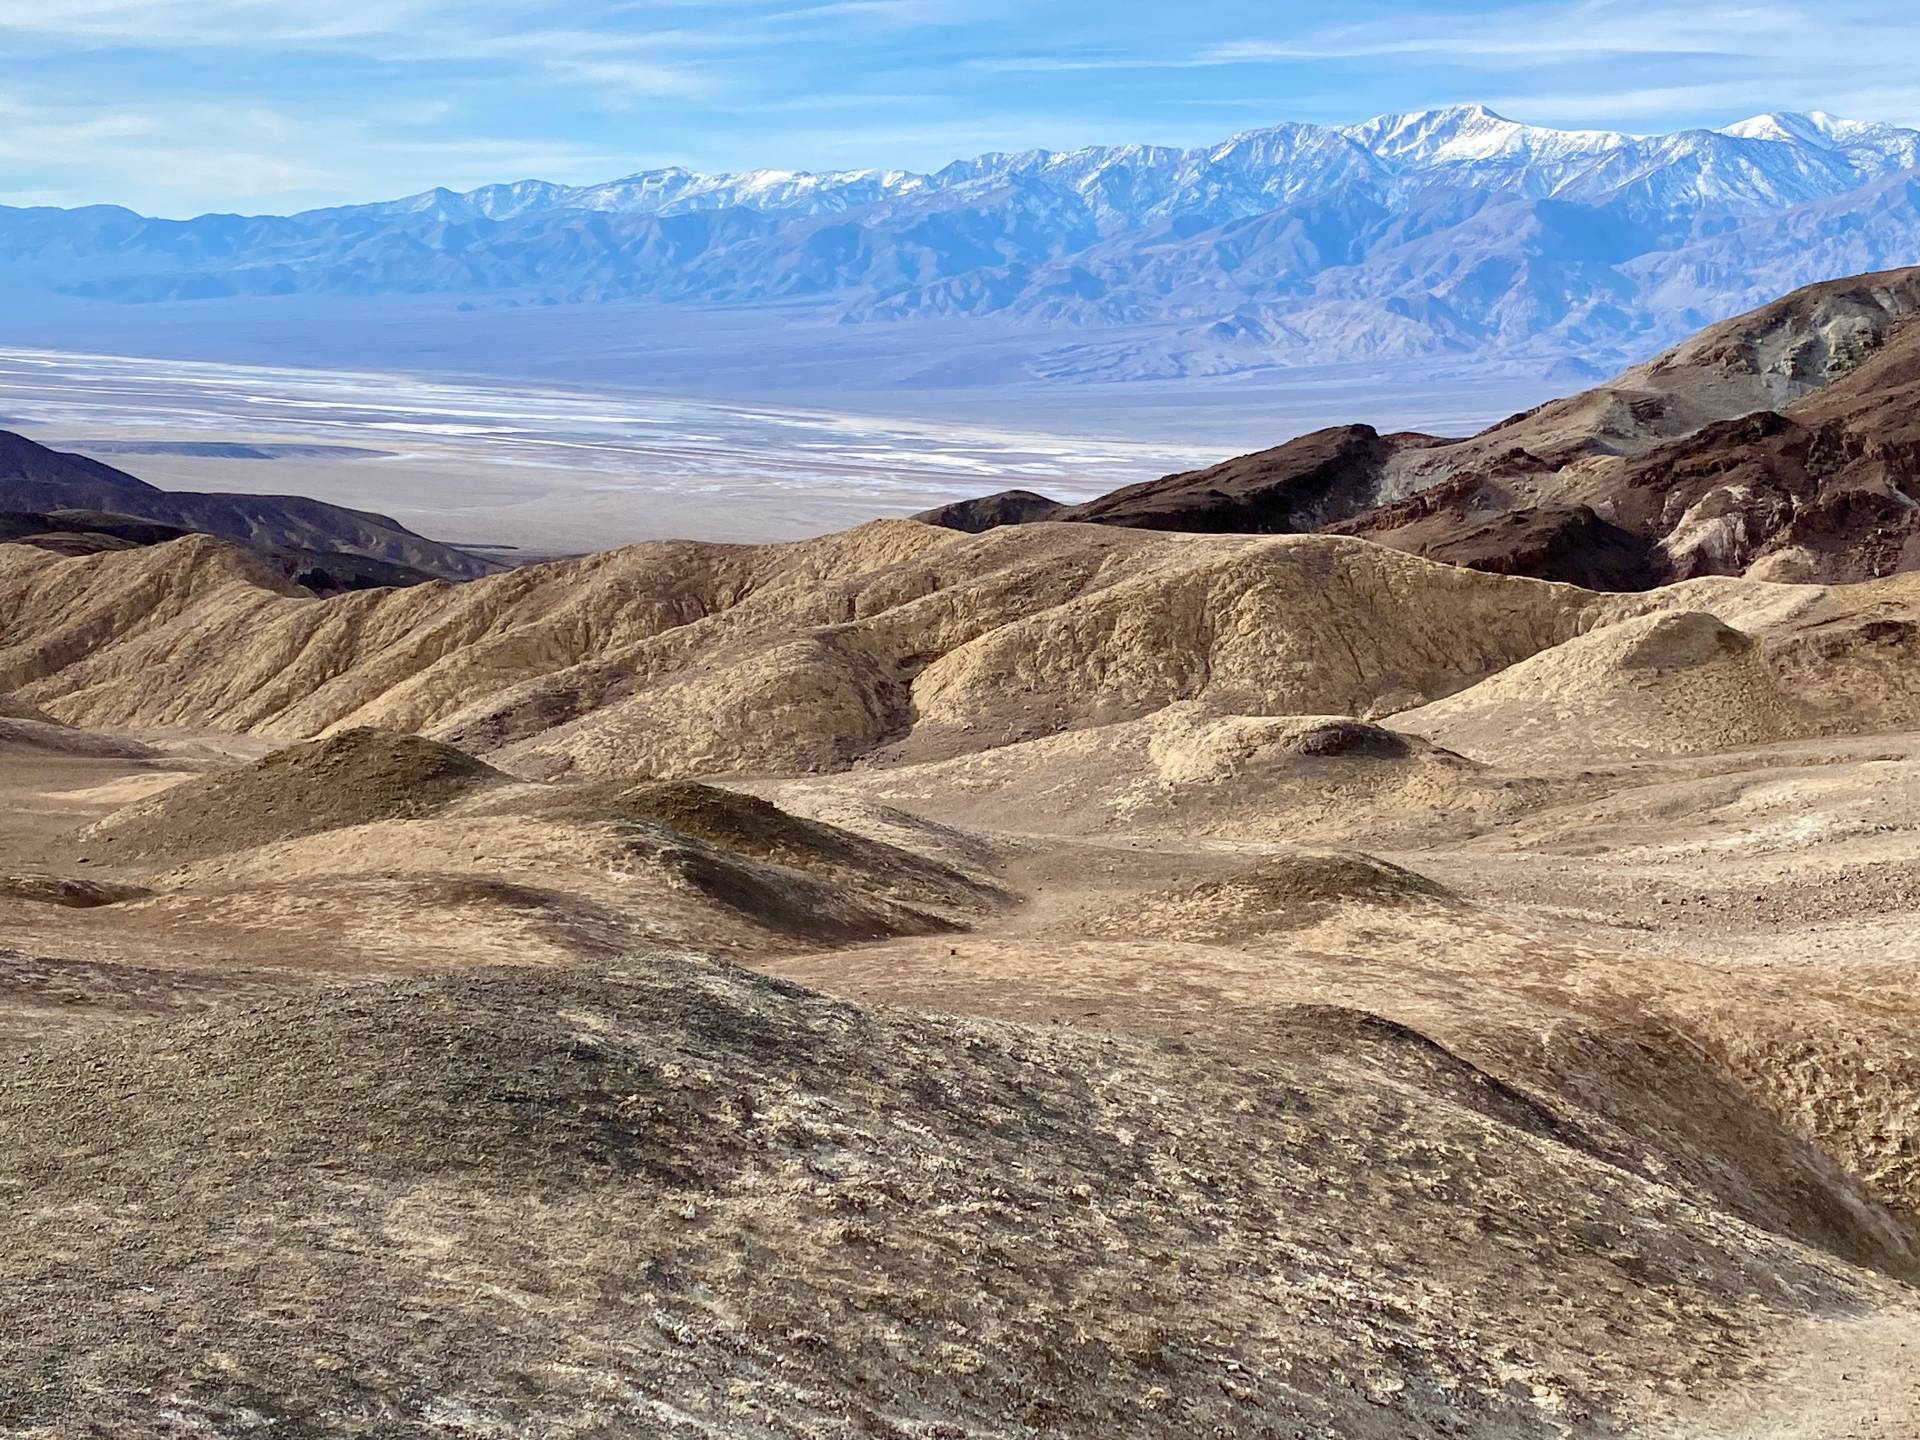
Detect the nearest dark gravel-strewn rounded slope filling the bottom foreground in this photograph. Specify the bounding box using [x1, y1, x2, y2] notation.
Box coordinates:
[0, 954, 1897, 1438]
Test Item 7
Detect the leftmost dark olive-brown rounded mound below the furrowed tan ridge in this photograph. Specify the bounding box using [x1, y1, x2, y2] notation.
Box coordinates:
[88, 730, 503, 860]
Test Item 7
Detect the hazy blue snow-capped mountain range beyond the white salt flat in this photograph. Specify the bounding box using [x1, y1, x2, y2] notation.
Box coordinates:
[0, 106, 1920, 376]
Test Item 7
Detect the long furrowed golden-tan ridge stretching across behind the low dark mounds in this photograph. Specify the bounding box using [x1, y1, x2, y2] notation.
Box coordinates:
[11, 520, 1920, 780]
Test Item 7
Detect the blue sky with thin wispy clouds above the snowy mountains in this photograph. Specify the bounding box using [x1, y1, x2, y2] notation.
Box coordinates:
[0, 0, 1920, 215]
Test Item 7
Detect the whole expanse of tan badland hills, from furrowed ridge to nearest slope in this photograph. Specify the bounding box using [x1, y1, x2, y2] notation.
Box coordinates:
[0, 522, 1920, 1440]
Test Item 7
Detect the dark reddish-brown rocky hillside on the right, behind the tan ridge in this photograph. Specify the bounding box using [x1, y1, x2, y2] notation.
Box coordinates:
[920, 269, 1920, 589]
